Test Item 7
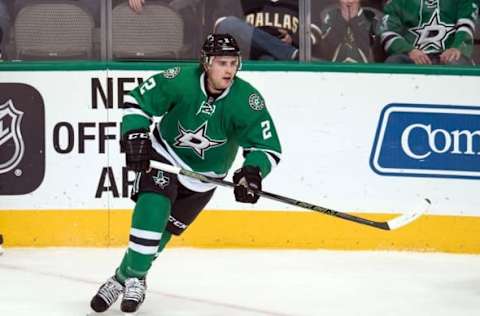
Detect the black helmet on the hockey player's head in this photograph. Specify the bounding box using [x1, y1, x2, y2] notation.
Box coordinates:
[200, 33, 241, 68]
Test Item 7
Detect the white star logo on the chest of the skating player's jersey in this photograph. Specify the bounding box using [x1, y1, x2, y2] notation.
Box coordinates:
[173, 121, 227, 159]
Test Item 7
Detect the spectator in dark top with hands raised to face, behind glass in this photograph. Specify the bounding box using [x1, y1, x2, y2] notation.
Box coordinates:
[320, 0, 382, 63]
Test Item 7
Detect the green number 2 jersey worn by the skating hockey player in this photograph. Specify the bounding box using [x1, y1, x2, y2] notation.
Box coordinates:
[122, 67, 281, 191]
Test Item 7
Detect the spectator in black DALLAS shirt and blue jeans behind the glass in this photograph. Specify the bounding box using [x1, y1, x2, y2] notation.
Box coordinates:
[212, 0, 320, 60]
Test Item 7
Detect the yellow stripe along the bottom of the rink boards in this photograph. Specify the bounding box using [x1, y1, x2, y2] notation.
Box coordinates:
[0, 210, 480, 253]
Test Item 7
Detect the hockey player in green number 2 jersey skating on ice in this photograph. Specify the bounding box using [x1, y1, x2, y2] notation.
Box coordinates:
[90, 34, 281, 313]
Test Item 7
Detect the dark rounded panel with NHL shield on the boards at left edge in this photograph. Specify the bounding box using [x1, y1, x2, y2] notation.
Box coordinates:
[0, 82, 45, 194]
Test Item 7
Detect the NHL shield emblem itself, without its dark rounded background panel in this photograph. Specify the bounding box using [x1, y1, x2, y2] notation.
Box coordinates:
[0, 100, 25, 174]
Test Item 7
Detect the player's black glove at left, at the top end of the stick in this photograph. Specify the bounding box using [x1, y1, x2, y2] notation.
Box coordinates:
[120, 129, 152, 172]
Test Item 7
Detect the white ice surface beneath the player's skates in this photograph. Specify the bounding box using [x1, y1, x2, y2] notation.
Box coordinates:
[0, 248, 480, 316]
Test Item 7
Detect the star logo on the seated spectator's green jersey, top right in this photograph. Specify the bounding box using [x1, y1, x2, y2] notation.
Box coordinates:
[410, 10, 455, 53]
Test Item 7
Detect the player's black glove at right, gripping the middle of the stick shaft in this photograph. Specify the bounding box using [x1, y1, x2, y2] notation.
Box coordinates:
[233, 166, 262, 204]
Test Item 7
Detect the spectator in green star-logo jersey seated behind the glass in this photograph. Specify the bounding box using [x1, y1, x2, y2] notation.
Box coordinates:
[380, 0, 476, 65]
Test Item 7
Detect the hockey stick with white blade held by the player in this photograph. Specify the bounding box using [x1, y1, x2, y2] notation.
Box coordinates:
[150, 160, 431, 230]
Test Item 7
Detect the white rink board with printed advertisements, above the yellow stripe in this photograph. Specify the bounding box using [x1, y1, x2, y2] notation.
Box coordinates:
[0, 70, 480, 251]
